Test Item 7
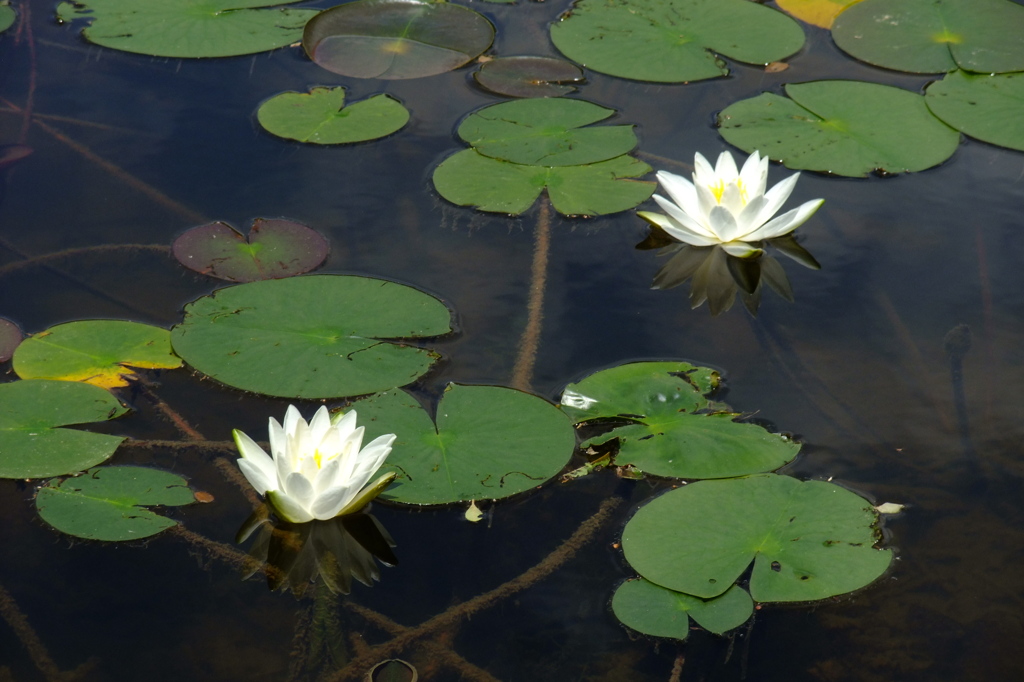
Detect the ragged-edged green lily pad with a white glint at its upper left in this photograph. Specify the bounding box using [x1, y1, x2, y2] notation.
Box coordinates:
[562, 363, 800, 478]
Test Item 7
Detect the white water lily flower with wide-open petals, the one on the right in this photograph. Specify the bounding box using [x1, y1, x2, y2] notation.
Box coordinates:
[637, 152, 824, 258]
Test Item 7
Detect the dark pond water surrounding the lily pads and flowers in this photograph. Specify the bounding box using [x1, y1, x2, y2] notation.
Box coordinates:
[0, 1, 1024, 682]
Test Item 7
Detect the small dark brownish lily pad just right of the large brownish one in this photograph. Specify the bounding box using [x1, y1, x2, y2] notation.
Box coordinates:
[473, 56, 585, 97]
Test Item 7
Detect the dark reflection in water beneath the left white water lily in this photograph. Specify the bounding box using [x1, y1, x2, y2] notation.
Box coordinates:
[236, 505, 398, 596]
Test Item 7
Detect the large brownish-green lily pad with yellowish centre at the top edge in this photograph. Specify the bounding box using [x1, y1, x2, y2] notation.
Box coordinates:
[302, 0, 495, 79]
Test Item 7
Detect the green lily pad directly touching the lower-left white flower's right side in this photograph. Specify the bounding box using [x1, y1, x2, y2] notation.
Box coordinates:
[352, 384, 575, 505]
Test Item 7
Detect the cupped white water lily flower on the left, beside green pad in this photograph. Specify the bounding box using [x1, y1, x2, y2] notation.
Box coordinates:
[232, 406, 395, 523]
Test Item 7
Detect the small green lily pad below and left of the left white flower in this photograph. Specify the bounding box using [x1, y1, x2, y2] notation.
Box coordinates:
[36, 467, 196, 542]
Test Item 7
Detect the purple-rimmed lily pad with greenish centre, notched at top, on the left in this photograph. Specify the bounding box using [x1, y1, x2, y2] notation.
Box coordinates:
[173, 218, 330, 282]
